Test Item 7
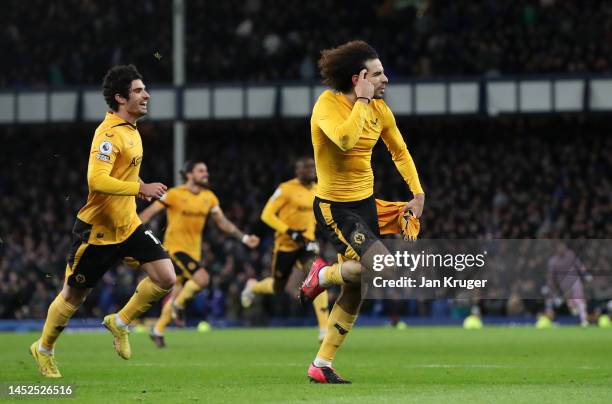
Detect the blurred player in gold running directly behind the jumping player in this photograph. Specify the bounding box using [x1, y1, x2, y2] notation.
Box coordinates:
[241, 157, 329, 341]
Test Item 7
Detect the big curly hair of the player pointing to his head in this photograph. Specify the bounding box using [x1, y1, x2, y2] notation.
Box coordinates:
[319, 41, 378, 93]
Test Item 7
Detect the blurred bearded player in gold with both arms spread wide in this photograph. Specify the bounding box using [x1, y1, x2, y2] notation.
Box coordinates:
[140, 161, 259, 348]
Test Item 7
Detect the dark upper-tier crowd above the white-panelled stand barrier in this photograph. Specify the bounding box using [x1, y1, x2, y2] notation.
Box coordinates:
[0, 0, 612, 88]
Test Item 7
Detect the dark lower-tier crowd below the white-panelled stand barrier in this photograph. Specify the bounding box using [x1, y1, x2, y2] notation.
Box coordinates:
[0, 116, 612, 324]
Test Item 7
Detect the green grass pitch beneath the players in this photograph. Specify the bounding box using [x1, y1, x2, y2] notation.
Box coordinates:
[0, 327, 612, 404]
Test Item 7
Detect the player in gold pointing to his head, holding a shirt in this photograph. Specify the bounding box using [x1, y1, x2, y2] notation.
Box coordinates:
[300, 41, 425, 383]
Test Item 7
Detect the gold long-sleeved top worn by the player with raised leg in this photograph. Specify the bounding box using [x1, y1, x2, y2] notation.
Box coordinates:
[310, 90, 423, 202]
